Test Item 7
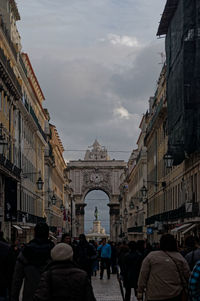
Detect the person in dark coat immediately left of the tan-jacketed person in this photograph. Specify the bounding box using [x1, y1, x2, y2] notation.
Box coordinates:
[122, 241, 143, 301]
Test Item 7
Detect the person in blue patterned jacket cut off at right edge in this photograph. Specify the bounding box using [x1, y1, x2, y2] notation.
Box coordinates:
[189, 261, 200, 301]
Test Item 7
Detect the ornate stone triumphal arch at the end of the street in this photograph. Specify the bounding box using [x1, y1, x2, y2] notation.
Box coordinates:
[67, 140, 126, 241]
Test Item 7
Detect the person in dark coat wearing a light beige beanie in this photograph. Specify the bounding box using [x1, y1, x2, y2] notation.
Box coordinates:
[34, 243, 96, 301]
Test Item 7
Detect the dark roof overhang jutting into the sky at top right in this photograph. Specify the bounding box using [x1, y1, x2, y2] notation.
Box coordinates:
[157, 0, 179, 36]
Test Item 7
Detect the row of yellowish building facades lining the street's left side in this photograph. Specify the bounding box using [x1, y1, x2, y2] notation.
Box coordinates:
[0, 0, 67, 242]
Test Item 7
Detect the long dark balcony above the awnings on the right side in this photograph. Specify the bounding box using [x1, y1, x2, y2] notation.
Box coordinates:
[146, 203, 199, 225]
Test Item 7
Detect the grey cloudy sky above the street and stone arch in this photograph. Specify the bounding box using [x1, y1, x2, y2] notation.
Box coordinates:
[17, 0, 166, 160]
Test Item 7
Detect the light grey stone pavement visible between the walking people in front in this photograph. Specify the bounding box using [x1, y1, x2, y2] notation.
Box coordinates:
[92, 274, 122, 301]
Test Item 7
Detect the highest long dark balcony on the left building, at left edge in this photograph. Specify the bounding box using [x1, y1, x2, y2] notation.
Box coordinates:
[0, 48, 22, 100]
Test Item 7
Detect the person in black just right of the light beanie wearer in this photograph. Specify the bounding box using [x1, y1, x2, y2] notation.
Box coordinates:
[75, 234, 97, 279]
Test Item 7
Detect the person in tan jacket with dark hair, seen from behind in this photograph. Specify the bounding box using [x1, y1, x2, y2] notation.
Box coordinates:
[137, 234, 190, 301]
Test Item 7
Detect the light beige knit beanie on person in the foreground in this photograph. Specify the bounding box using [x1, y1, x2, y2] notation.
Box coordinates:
[51, 243, 73, 261]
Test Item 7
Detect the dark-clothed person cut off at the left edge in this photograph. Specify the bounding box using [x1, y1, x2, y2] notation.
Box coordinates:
[0, 233, 15, 301]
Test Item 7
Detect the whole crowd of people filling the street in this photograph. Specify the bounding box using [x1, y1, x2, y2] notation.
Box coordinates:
[0, 223, 200, 301]
